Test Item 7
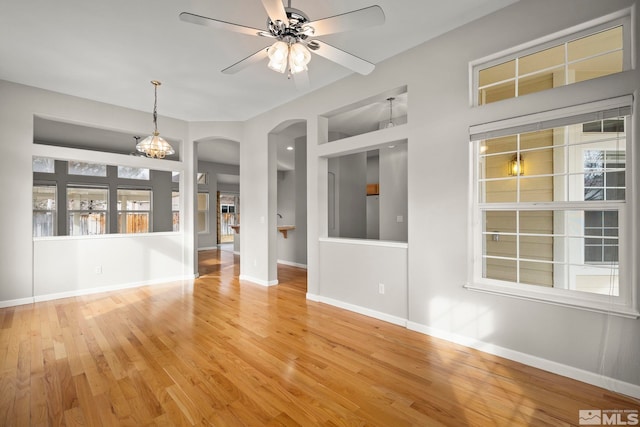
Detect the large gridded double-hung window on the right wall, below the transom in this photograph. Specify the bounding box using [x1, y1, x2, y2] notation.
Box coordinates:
[469, 97, 632, 312]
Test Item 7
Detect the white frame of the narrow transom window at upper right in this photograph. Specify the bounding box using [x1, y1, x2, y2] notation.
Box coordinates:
[469, 9, 633, 107]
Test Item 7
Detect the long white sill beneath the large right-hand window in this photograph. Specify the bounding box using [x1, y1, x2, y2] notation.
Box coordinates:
[464, 283, 640, 319]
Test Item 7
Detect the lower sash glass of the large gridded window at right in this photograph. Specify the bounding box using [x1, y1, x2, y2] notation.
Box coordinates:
[483, 210, 619, 295]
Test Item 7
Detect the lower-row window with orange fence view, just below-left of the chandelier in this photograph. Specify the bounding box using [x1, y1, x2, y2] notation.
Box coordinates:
[118, 189, 151, 233]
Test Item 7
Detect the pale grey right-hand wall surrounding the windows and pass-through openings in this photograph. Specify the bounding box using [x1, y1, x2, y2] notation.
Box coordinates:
[241, 0, 640, 396]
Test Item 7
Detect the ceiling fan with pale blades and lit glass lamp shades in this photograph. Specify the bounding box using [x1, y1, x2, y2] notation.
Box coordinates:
[180, 0, 385, 85]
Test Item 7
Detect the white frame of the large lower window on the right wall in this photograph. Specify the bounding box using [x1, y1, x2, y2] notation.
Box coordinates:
[465, 95, 640, 318]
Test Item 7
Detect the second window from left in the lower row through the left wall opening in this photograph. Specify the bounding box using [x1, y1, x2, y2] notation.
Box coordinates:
[67, 187, 109, 236]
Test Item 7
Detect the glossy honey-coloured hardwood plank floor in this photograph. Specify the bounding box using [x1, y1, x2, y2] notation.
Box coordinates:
[0, 250, 640, 426]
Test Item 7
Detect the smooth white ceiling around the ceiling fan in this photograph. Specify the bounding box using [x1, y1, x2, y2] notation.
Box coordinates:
[0, 0, 515, 121]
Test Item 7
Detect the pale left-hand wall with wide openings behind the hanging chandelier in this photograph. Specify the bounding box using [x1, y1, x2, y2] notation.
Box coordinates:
[0, 81, 242, 306]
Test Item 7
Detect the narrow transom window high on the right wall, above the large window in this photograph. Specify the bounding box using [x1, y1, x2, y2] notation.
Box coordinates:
[473, 19, 631, 105]
